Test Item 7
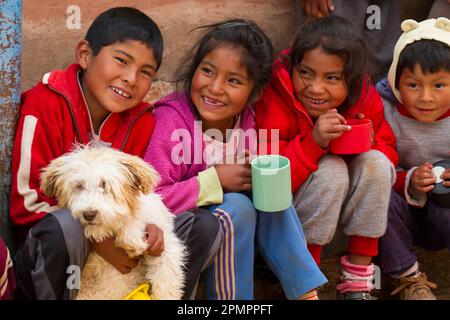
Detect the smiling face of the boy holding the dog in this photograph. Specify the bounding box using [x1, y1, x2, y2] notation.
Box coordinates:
[78, 40, 157, 120]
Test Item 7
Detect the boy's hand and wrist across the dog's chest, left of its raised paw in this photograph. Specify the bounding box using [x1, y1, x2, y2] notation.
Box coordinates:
[91, 238, 139, 274]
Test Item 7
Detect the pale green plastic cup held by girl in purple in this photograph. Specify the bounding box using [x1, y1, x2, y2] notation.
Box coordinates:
[251, 154, 292, 212]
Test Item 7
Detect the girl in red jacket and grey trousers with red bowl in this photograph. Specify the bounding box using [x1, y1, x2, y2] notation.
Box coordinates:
[255, 16, 397, 299]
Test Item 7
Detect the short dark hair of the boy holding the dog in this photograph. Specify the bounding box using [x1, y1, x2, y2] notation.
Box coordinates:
[85, 7, 164, 68]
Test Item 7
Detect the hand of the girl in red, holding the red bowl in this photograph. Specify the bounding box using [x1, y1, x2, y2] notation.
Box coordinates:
[312, 109, 351, 149]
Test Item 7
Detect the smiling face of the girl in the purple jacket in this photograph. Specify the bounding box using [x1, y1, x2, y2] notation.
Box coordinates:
[191, 45, 254, 131]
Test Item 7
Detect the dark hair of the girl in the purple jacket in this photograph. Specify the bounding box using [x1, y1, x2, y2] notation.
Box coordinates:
[176, 19, 274, 101]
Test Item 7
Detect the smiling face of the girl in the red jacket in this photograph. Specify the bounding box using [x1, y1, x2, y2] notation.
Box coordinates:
[292, 47, 348, 119]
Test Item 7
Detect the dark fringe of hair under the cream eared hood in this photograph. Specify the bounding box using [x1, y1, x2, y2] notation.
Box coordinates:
[395, 39, 450, 88]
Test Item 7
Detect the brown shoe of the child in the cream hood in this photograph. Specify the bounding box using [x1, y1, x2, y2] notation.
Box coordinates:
[391, 272, 437, 300]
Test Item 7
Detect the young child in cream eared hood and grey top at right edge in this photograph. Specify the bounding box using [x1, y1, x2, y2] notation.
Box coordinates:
[377, 17, 450, 300]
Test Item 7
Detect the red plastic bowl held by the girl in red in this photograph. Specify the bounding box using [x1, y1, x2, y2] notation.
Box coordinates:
[330, 119, 372, 154]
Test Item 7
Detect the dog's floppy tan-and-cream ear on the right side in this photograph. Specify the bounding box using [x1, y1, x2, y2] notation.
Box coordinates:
[120, 155, 159, 194]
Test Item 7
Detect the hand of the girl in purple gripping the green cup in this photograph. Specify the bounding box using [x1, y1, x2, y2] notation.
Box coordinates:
[214, 150, 252, 192]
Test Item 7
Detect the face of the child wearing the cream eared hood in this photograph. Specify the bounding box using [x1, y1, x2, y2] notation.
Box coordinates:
[398, 64, 450, 122]
